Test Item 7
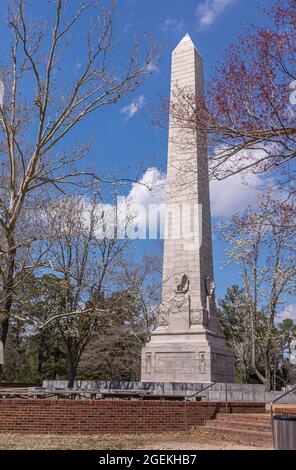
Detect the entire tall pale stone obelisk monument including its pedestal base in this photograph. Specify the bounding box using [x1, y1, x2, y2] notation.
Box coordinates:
[141, 34, 234, 383]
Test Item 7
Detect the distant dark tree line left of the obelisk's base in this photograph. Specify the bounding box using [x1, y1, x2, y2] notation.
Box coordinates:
[2, 253, 160, 387]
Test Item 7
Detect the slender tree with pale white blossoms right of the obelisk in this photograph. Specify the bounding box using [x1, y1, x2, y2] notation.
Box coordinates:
[224, 190, 296, 390]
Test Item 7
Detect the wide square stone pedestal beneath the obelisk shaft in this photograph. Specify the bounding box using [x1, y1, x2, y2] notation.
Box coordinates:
[141, 327, 234, 383]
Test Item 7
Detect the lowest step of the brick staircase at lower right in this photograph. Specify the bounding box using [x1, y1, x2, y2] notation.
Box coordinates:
[196, 423, 272, 447]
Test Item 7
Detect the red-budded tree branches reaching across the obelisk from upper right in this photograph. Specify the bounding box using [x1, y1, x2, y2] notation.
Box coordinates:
[171, 0, 296, 182]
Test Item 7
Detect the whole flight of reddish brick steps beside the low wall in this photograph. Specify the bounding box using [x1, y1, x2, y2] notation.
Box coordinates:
[197, 413, 272, 447]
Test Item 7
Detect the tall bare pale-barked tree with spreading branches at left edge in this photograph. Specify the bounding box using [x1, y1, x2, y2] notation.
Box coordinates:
[0, 0, 156, 352]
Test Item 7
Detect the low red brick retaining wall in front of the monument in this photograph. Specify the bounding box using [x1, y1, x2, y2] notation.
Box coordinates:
[0, 399, 265, 434]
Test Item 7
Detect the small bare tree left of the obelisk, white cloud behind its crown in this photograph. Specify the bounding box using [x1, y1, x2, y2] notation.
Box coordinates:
[19, 193, 133, 387]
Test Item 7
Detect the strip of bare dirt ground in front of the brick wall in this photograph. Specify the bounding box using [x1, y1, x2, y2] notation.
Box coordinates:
[0, 432, 268, 450]
